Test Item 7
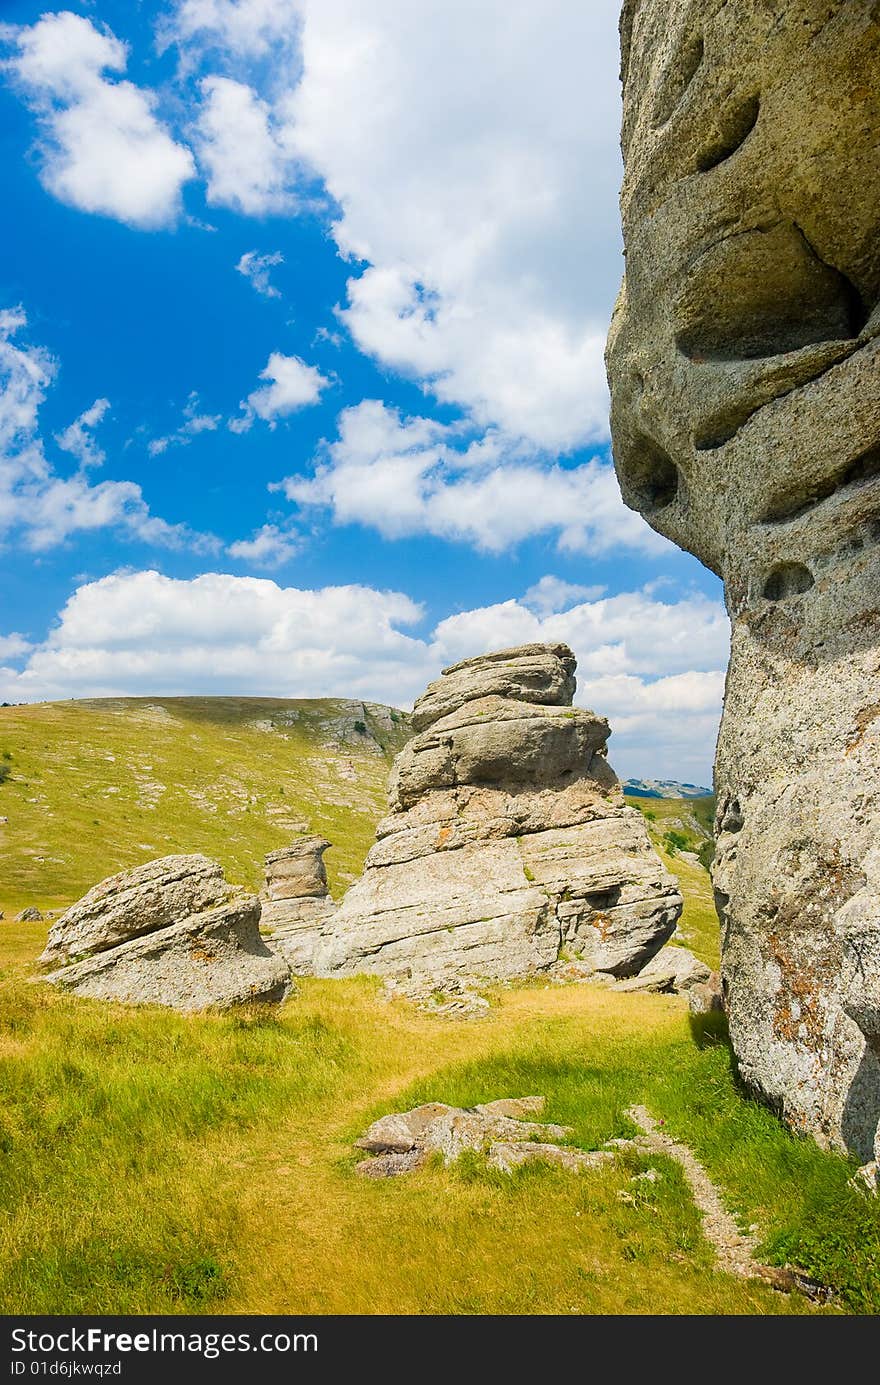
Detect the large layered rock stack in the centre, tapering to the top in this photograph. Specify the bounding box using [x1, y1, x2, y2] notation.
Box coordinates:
[315, 644, 682, 979]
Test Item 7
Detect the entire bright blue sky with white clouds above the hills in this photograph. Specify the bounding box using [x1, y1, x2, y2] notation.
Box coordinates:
[0, 0, 728, 781]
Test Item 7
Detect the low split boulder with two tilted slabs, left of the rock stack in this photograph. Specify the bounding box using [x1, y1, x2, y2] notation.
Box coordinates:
[40, 856, 291, 1010]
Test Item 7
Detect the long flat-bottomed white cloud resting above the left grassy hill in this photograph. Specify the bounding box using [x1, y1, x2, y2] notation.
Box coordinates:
[0, 572, 431, 701]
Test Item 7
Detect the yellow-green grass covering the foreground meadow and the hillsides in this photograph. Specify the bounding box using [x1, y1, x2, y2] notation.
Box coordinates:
[0, 704, 880, 1314]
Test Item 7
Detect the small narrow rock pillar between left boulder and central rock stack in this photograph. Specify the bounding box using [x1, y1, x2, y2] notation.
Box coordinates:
[261, 837, 335, 975]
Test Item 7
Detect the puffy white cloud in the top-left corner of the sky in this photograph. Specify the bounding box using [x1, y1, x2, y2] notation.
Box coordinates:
[0, 11, 195, 229]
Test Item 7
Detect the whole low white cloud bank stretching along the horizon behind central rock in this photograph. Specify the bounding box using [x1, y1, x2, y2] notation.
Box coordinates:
[0, 571, 728, 783]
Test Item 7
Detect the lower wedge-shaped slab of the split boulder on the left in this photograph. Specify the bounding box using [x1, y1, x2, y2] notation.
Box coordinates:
[44, 895, 291, 1011]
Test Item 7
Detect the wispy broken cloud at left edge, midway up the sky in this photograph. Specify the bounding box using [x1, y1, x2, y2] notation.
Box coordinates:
[0, 307, 213, 551]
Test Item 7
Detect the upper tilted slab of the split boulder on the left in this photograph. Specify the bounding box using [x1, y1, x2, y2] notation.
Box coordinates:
[40, 856, 230, 965]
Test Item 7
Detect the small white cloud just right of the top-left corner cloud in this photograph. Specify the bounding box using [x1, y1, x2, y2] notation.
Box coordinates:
[197, 76, 298, 216]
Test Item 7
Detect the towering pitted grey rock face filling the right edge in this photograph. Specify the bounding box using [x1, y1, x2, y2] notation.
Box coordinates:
[608, 0, 880, 1158]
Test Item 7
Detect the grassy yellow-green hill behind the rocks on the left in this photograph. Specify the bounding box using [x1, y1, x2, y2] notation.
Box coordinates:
[0, 697, 412, 918]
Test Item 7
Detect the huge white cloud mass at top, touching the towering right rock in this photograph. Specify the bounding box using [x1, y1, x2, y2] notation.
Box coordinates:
[285, 0, 621, 450]
